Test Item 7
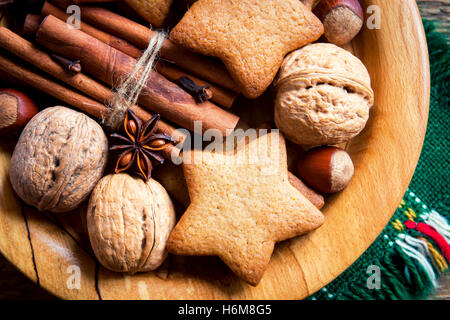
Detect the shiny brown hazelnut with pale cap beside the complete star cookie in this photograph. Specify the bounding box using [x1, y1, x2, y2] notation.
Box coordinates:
[296, 147, 354, 193]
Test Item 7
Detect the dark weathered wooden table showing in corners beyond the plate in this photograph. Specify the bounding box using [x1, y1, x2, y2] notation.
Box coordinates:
[0, 0, 450, 300]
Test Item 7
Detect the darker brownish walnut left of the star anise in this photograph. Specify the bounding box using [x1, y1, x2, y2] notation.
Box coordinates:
[9, 106, 108, 212]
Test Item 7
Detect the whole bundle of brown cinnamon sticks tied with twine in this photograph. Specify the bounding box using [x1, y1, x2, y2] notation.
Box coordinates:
[0, 0, 243, 158]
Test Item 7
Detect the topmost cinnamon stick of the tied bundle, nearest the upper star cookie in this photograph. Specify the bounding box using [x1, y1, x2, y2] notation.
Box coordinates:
[48, 0, 240, 92]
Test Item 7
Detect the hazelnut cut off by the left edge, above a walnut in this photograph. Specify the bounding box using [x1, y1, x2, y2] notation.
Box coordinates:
[0, 88, 39, 133]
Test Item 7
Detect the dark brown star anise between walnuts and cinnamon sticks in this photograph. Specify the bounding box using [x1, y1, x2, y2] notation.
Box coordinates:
[110, 110, 174, 180]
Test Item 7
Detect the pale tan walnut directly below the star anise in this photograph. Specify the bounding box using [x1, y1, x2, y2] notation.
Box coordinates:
[87, 173, 176, 274]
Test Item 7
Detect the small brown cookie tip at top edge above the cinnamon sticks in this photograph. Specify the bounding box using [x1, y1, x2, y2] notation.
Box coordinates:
[125, 0, 173, 27]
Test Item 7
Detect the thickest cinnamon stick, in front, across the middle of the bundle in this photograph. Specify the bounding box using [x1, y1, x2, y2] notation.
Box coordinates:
[36, 16, 239, 135]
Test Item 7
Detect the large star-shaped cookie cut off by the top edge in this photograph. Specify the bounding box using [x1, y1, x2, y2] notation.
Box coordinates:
[170, 0, 323, 98]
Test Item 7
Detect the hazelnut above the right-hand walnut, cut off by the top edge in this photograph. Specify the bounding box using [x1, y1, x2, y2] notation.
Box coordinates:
[314, 0, 364, 46]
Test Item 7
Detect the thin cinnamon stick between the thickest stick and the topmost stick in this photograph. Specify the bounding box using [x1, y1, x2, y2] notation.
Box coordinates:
[40, 1, 238, 108]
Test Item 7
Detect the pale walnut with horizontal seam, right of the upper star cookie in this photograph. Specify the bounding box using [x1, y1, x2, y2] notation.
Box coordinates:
[275, 43, 374, 146]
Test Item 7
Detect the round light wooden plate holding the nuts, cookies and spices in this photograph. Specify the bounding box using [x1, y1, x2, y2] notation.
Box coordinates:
[0, 0, 429, 299]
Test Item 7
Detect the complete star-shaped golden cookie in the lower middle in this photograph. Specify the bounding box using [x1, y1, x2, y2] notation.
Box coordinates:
[167, 132, 324, 285]
